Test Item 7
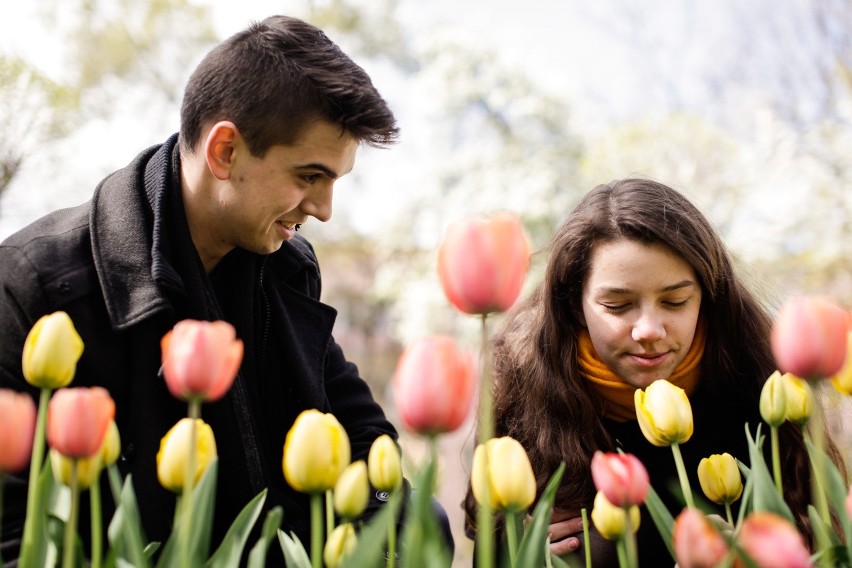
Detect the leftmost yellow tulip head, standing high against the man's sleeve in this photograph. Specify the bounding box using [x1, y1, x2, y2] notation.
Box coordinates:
[21, 312, 83, 389]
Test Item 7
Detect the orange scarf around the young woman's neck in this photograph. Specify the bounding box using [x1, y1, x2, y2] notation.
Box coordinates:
[578, 320, 707, 422]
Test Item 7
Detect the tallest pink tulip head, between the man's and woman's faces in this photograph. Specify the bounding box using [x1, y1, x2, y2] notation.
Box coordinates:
[438, 213, 530, 314]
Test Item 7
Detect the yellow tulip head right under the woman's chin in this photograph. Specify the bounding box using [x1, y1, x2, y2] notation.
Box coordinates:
[633, 379, 692, 447]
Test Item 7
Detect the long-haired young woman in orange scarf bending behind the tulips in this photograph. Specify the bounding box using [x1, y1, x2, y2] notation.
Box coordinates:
[465, 179, 836, 566]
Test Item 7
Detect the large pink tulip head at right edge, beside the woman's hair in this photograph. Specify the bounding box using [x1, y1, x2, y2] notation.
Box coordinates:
[772, 296, 850, 379]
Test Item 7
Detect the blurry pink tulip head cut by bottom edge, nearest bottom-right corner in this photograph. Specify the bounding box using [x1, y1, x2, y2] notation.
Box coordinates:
[737, 511, 813, 568]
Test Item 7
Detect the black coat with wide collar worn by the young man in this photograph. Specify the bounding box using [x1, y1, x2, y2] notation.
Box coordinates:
[0, 136, 396, 559]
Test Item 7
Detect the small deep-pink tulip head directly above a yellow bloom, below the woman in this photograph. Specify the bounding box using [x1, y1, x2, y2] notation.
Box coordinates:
[592, 451, 650, 507]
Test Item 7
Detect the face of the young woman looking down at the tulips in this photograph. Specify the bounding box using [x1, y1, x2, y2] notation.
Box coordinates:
[583, 239, 701, 389]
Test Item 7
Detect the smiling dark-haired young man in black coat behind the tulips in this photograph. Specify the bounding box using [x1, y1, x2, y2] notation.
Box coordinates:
[0, 16, 398, 560]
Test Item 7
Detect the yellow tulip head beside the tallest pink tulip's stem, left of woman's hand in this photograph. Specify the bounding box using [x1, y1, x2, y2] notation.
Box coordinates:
[471, 436, 535, 512]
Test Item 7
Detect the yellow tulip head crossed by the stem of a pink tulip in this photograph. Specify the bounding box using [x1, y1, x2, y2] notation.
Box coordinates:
[157, 418, 217, 493]
